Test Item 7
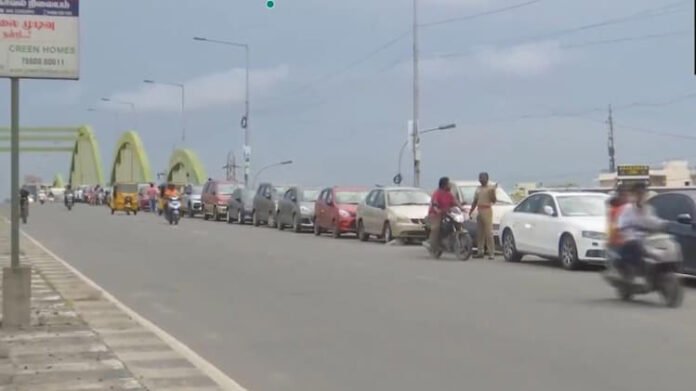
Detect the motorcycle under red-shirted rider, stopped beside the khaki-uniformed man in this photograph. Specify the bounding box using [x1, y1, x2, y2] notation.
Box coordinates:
[426, 207, 474, 261]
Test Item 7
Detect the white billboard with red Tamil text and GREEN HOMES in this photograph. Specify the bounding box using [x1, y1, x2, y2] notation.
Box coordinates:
[0, 0, 80, 79]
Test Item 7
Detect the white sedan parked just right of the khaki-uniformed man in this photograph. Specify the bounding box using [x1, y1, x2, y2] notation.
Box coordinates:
[501, 191, 609, 270]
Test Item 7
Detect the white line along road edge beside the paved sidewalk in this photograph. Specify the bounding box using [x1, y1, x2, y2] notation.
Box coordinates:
[22, 225, 247, 391]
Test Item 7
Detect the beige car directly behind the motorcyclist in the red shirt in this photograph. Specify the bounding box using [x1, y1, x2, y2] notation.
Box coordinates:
[357, 187, 430, 243]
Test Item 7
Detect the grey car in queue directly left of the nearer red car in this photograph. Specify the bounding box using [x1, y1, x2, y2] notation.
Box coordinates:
[276, 186, 320, 232]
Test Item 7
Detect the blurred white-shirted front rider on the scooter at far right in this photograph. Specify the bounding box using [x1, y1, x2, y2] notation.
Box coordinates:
[614, 182, 667, 274]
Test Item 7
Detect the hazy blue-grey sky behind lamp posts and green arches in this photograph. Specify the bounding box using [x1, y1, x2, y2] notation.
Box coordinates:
[0, 0, 696, 196]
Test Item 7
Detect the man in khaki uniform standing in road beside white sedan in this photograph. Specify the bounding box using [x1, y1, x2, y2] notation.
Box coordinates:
[469, 172, 498, 259]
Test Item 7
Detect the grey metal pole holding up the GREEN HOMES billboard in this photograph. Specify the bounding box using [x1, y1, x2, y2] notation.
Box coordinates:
[10, 77, 20, 269]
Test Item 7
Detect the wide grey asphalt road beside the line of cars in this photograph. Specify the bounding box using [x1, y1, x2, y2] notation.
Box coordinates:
[12, 205, 696, 391]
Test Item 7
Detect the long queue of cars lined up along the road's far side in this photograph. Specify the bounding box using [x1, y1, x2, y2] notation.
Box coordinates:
[135, 180, 696, 275]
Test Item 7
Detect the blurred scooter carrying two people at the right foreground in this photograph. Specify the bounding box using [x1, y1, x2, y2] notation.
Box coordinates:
[603, 233, 684, 308]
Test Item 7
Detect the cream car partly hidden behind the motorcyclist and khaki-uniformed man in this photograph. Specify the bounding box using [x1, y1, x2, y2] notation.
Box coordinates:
[451, 181, 515, 248]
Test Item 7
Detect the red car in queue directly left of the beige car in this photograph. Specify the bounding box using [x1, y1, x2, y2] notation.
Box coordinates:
[314, 187, 368, 238]
